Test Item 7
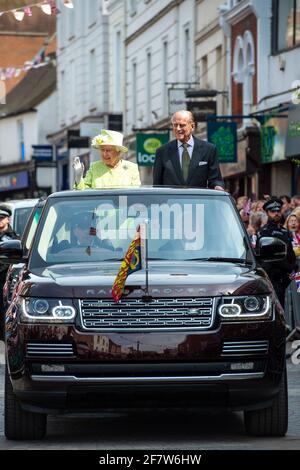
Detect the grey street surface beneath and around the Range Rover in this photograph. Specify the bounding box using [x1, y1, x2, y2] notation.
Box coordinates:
[0, 342, 300, 450]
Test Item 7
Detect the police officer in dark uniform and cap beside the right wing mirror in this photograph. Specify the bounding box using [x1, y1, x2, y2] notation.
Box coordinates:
[257, 197, 296, 307]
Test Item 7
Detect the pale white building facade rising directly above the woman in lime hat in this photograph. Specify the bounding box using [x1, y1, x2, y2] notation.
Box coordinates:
[53, 0, 124, 189]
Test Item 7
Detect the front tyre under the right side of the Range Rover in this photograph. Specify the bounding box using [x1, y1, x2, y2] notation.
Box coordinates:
[244, 368, 288, 437]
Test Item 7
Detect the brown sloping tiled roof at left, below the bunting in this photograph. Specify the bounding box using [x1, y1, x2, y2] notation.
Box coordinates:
[0, 62, 56, 119]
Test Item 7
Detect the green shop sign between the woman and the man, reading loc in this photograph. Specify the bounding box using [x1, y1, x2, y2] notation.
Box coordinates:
[136, 132, 169, 166]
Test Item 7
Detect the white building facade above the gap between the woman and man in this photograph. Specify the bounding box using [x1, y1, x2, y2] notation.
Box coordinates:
[124, 0, 196, 183]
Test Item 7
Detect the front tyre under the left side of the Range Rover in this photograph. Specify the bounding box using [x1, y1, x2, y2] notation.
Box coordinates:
[4, 366, 47, 440]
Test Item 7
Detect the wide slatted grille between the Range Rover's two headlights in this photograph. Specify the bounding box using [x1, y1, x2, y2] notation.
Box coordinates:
[80, 297, 215, 330]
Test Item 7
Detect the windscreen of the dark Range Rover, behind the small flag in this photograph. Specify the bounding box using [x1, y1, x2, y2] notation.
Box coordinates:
[30, 193, 247, 269]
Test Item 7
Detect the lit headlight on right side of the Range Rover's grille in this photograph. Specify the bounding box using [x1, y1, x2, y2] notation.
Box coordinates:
[218, 295, 272, 321]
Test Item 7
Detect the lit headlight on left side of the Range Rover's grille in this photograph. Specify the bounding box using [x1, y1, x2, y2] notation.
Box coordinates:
[21, 297, 76, 323]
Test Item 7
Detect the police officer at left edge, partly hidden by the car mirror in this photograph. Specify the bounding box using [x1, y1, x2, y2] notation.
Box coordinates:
[0, 204, 19, 339]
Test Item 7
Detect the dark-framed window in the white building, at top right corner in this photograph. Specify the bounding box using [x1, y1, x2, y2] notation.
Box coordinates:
[273, 0, 300, 52]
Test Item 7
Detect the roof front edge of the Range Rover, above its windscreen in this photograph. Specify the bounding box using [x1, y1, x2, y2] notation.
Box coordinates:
[48, 186, 230, 199]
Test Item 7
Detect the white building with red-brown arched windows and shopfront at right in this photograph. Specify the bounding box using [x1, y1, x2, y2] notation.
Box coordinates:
[220, 0, 300, 196]
